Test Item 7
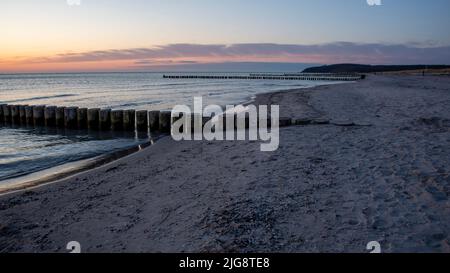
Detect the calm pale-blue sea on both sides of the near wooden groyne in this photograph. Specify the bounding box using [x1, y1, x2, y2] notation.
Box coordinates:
[0, 73, 338, 183]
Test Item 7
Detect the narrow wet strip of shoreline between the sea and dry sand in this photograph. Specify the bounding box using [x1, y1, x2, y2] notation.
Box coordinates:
[0, 79, 342, 194]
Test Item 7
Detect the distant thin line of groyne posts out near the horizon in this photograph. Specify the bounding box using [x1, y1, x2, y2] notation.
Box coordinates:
[163, 73, 365, 81]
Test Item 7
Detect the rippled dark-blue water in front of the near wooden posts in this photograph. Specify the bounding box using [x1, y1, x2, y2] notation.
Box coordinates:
[0, 126, 148, 180]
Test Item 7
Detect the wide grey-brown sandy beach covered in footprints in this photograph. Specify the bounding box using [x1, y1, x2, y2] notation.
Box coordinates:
[0, 75, 450, 252]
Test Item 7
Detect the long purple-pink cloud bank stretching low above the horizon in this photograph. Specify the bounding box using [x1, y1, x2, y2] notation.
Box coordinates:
[10, 42, 450, 66]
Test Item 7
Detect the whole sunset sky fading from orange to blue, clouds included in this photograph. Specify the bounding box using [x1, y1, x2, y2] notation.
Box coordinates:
[0, 0, 450, 73]
